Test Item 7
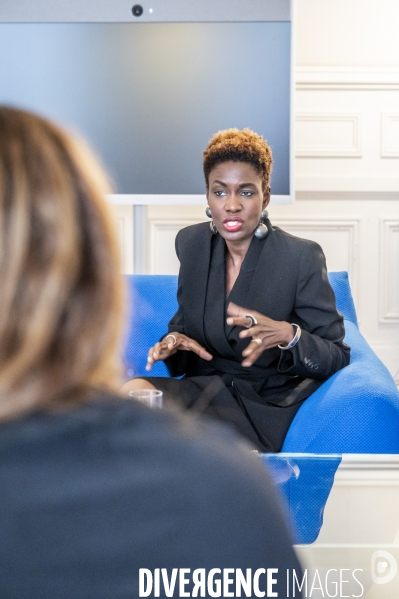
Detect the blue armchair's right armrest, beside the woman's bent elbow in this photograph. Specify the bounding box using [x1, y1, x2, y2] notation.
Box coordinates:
[282, 320, 399, 453]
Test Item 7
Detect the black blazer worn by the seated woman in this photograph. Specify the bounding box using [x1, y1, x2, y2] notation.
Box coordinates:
[166, 221, 350, 405]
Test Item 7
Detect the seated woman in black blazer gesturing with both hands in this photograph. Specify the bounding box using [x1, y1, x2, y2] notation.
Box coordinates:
[124, 129, 350, 452]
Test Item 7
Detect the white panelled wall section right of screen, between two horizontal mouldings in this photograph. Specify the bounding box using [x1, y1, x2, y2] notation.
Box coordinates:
[295, 68, 399, 194]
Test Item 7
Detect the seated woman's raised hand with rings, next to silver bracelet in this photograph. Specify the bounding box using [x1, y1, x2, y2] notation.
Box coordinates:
[226, 302, 295, 366]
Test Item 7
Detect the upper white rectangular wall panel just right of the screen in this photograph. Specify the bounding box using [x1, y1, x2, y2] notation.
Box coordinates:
[295, 112, 362, 158]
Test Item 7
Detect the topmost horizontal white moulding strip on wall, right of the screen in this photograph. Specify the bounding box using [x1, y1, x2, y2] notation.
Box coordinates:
[296, 65, 399, 91]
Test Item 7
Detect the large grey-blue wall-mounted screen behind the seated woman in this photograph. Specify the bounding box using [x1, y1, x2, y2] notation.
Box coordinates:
[0, 0, 293, 202]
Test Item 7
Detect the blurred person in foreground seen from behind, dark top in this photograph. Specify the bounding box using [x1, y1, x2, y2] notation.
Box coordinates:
[0, 107, 299, 599]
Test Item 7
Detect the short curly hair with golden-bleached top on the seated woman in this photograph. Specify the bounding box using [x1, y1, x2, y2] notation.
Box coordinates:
[204, 129, 273, 191]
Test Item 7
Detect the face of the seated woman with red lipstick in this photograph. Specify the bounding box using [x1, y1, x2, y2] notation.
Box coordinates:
[206, 161, 270, 243]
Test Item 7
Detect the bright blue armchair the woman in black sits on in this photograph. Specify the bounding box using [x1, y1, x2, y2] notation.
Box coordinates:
[123, 272, 399, 454]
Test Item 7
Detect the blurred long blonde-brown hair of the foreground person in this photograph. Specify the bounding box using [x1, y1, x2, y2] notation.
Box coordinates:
[0, 107, 122, 419]
